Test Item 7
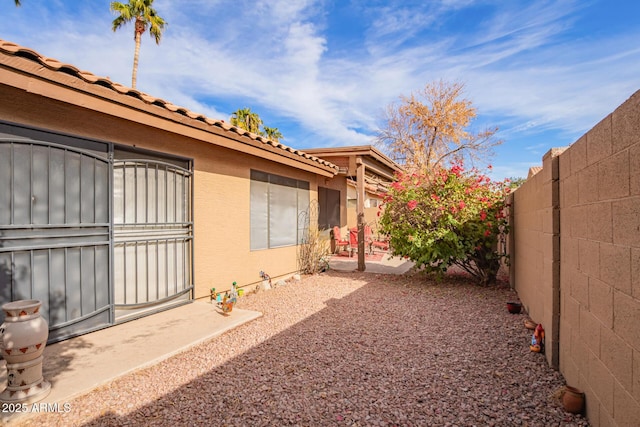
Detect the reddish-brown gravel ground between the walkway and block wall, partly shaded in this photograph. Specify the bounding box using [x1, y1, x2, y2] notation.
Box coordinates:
[12, 271, 588, 427]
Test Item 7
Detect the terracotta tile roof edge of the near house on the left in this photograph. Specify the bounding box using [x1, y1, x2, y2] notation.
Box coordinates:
[0, 39, 338, 174]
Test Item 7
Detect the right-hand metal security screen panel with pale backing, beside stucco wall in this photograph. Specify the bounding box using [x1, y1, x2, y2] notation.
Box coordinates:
[113, 158, 193, 321]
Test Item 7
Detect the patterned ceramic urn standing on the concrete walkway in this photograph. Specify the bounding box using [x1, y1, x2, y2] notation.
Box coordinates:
[0, 300, 51, 403]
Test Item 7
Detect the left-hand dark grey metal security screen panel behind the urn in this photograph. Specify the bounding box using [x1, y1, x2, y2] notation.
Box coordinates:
[0, 138, 111, 341]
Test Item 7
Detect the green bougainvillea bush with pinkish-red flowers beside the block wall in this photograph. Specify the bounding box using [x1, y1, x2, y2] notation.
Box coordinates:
[379, 164, 510, 285]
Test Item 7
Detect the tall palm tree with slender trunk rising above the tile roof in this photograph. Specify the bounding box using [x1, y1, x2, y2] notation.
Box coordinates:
[110, 0, 167, 89]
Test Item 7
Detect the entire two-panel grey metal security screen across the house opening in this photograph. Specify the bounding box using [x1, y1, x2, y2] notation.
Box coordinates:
[0, 122, 193, 342]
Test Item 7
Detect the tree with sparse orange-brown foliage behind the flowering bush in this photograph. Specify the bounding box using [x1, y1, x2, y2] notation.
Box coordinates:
[376, 80, 502, 173]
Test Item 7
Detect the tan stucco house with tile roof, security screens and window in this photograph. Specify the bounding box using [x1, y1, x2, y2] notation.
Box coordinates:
[0, 40, 339, 341]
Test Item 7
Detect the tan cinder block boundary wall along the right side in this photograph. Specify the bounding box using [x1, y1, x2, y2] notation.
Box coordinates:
[511, 91, 640, 426]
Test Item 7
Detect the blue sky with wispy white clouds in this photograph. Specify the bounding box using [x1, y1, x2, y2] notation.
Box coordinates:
[0, 0, 640, 179]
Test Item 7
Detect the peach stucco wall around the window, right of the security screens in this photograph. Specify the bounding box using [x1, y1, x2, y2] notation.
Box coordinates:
[194, 144, 317, 297]
